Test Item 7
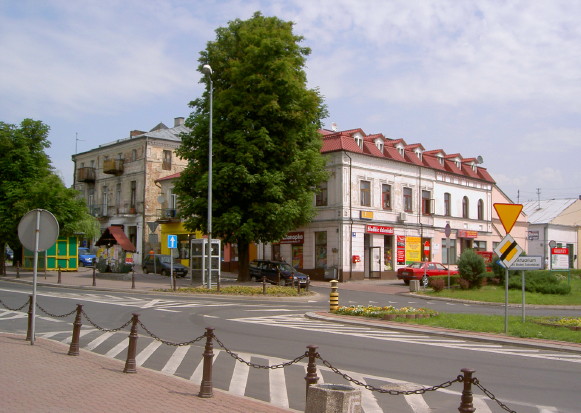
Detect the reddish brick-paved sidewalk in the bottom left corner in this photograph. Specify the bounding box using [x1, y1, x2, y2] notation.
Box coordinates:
[0, 333, 293, 413]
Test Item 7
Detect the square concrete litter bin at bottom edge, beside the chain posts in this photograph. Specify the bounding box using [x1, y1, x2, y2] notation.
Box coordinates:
[305, 384, 361, 413]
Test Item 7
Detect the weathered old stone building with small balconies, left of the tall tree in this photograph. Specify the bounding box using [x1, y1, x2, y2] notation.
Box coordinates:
[72, 117, 188, 264]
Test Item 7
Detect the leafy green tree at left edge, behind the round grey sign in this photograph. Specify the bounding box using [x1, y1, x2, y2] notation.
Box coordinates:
[0, 119, 99, 273]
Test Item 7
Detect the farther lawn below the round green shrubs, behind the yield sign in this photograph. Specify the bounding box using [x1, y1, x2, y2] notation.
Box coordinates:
[420, 273, 581, 305]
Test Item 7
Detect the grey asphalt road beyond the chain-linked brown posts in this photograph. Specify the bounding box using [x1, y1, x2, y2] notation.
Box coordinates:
[0, 282, 581, 413]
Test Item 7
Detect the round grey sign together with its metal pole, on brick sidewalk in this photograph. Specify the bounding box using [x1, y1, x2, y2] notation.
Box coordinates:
[18, 209, 59, 345]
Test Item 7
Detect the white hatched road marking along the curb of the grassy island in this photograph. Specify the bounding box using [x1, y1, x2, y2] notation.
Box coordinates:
[230, 314, 581, 363]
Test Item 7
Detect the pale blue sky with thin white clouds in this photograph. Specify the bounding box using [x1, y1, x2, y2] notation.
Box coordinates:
[0, 0, 581, 203]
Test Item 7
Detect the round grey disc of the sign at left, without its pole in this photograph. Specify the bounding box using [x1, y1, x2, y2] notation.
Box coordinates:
[18, 209, 59, 251]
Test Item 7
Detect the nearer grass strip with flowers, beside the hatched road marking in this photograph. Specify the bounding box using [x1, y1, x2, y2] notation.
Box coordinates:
[398, 313, 581, 343]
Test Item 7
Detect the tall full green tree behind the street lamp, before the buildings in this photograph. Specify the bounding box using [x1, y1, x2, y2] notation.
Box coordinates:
[176, 13, 327, 281]
